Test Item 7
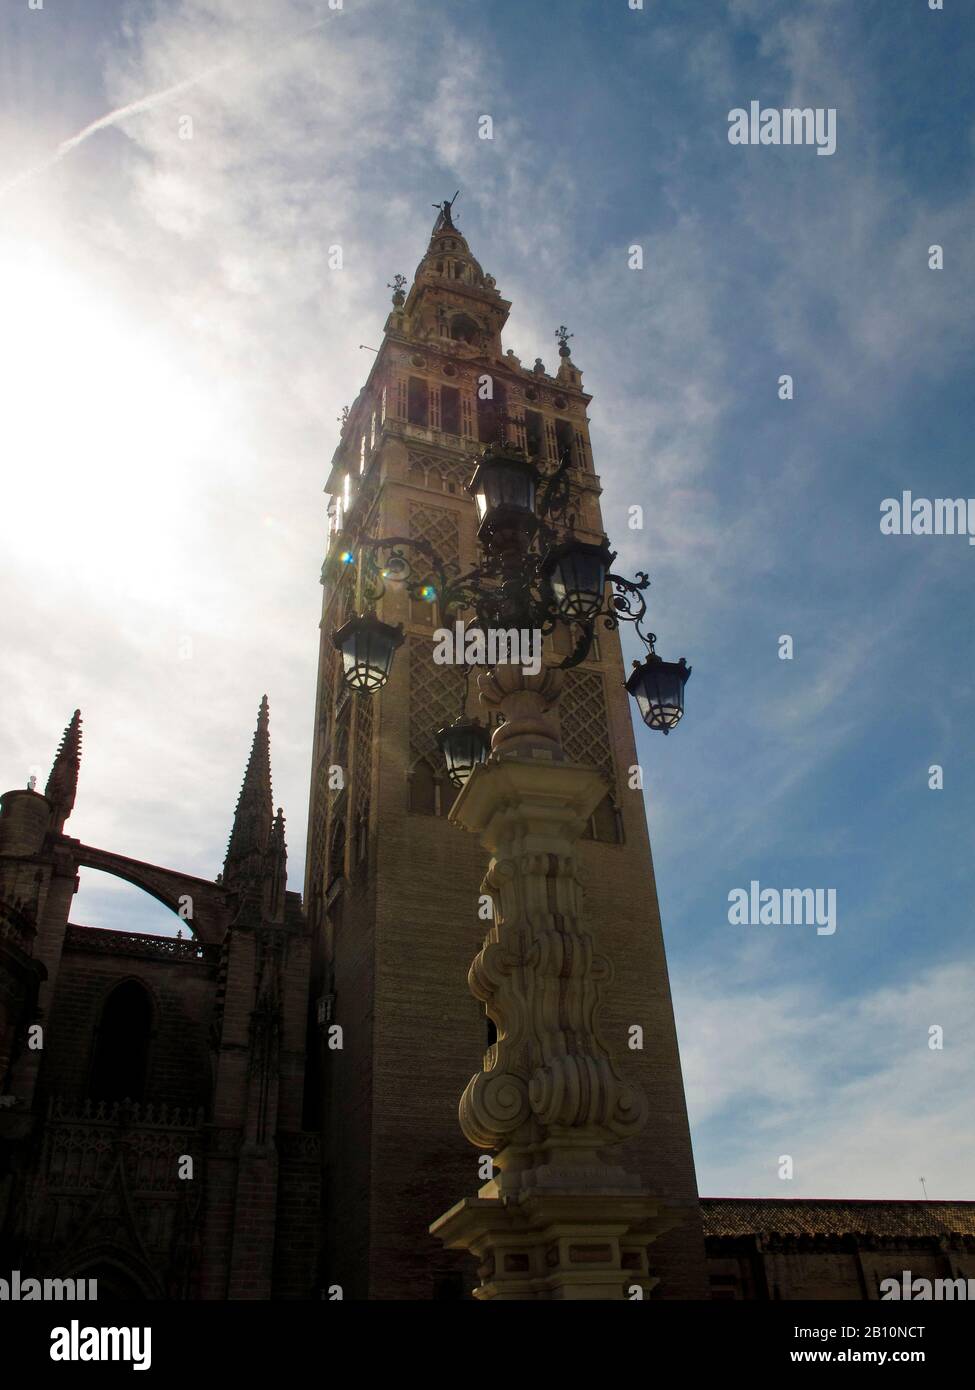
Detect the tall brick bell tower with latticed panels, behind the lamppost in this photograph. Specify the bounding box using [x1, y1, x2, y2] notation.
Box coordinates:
[306, 204, 705, 1298]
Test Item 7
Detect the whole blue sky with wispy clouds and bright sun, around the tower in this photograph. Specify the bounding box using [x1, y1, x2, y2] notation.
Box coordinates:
[0, 0, 975, 1200]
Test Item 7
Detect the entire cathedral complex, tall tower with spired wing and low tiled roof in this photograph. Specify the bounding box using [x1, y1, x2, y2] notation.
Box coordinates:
[0, 204, 975, 1300]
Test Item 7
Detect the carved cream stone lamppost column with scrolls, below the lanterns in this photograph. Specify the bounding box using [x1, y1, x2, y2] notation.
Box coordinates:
[430, 666, 680, 1300]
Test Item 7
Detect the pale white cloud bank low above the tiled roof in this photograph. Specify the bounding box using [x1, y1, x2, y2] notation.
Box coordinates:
[680, 945, 975, 1201]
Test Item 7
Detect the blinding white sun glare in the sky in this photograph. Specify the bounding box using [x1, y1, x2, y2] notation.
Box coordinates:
[0, 245, 213, 596]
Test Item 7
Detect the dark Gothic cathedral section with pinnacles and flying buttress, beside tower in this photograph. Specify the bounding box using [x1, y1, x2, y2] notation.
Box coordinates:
[0, 699, 320, 1298]
